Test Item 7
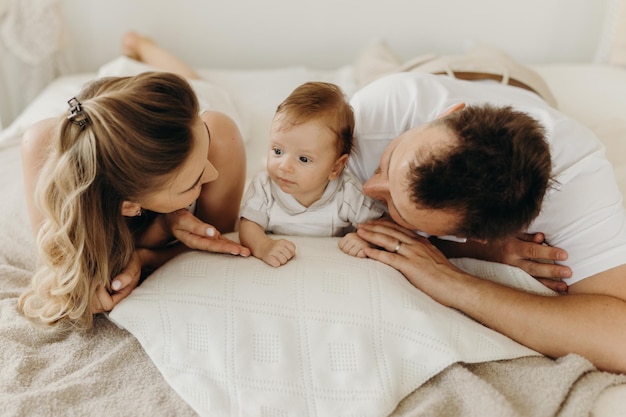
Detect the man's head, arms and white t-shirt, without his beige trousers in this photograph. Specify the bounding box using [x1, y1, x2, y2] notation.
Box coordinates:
[349, 73, 626, 372]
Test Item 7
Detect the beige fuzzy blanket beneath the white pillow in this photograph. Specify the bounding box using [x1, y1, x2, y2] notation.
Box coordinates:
[0, 142, 626, 417]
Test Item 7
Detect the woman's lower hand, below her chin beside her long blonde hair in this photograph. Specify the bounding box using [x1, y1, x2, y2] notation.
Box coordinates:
[91, 249, 147, 314]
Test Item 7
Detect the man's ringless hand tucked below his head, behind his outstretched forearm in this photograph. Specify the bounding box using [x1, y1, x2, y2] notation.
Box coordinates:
[486, 233, 572, 293]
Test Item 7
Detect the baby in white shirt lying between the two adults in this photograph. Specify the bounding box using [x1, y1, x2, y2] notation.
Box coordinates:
[239, 82, 384, 267]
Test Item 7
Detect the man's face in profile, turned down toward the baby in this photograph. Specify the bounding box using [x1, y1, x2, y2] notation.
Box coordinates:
[363, 125, 460, 236]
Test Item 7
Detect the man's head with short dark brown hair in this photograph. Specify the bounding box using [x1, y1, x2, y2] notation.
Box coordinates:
[364, 105, 551, 240]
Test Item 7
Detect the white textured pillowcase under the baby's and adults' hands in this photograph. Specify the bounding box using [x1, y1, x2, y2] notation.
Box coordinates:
[109, 237, 543, 417]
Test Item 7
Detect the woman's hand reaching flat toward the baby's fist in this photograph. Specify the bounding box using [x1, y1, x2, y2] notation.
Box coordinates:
[165, 209, 250, 256]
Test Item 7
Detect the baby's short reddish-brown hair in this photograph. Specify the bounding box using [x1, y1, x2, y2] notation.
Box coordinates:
[276, 81, 354, 155]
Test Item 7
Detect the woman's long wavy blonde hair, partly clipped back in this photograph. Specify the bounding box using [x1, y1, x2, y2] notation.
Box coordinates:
[19, 72, 198, 328]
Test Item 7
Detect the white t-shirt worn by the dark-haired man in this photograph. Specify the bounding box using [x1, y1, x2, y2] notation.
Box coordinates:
[348, 72, 626, 285]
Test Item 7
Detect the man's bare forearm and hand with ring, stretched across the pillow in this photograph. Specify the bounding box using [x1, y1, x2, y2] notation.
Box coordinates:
[358, 224, 626, 373]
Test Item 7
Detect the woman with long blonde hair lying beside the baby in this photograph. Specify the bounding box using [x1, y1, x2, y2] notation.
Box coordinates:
[20, 33, 250, 328]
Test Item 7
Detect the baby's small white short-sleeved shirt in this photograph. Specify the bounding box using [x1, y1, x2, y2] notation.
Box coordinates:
[240, 171, 385, 236]
